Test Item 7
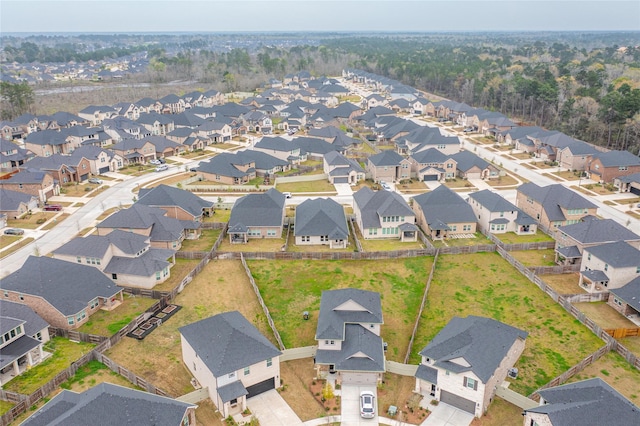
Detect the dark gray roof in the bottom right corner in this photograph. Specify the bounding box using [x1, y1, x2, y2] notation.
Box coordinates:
[525, 378, 640, 426]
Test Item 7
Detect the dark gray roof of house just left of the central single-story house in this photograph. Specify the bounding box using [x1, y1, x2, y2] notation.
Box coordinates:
[229, 189, 285, 228]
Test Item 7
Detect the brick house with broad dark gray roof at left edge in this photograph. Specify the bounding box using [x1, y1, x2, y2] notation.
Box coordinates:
[0, 256, 123, 330]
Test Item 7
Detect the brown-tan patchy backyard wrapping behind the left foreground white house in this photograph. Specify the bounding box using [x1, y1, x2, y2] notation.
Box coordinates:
[106, 260, 275, 396]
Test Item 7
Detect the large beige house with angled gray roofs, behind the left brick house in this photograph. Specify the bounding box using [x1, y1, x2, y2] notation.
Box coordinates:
[53, 230, 175, 289]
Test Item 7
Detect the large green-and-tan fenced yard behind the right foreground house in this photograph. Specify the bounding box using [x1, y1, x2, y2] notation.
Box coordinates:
[411, 253, 603, 394]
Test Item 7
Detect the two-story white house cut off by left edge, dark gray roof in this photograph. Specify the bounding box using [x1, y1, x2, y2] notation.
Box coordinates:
[0, 299, 49, 385]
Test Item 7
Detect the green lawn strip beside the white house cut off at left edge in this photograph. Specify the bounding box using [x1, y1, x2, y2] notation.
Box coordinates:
[2, 337, 95, 395]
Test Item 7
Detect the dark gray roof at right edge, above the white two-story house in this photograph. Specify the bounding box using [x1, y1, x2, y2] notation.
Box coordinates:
[558, 219, 640, 244]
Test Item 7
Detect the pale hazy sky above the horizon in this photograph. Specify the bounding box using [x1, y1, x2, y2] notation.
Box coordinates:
[0, 0, 640, 33]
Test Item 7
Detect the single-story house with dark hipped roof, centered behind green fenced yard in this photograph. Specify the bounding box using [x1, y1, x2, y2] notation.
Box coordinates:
[294, 198, 349, 249]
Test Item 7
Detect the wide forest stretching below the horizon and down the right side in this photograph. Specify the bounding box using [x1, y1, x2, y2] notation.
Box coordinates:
[3, 32, 640, 154]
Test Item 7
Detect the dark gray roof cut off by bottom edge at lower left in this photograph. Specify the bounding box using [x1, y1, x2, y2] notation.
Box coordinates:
[22, 383, 195, 426]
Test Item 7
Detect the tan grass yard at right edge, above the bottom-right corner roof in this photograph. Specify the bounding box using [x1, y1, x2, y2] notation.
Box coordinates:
[569, 352, 640, 406]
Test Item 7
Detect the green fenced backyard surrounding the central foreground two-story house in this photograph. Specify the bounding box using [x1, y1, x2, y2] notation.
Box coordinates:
[249, 257, 433, 361]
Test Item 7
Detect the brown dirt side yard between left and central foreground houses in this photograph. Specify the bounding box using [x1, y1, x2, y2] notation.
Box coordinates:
[280, 358, 327, 421]
